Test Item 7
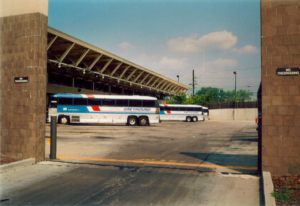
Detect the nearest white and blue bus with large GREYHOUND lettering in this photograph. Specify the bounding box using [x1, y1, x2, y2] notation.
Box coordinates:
[48, 94, 159, 126]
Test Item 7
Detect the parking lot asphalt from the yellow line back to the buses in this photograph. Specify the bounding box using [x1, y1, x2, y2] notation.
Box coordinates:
[46, 121, 257, 174]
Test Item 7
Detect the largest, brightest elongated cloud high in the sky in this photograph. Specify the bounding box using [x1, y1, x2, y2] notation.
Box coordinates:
[167, 31, 237, 53]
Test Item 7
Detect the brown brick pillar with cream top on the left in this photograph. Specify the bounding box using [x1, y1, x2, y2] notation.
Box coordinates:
[0, 0, 48, 161]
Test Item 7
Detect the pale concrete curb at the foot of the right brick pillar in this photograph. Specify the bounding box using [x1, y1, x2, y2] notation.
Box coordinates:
[262, 172, 276, 206]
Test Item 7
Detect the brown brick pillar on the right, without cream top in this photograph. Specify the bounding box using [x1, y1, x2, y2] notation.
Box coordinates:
[261, 0, 300, 175]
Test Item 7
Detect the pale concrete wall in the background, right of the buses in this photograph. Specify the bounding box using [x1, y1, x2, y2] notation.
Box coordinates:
[209, 108, 257, 121]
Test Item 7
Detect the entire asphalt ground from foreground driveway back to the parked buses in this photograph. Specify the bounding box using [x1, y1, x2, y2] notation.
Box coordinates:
[0, 121, 263, 206]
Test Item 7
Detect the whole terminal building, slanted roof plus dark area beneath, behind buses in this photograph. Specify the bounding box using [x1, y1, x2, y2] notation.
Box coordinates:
[47, 27, 189, 102]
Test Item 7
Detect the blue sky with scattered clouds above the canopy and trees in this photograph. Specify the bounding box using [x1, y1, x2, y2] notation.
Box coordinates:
[48, 0, 261, 95]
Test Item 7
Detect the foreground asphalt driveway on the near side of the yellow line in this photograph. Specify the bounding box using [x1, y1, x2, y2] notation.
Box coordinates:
[0, 162, 260, 206]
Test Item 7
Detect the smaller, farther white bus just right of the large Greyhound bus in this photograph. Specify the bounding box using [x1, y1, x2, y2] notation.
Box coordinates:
[159, 104, 204, 122]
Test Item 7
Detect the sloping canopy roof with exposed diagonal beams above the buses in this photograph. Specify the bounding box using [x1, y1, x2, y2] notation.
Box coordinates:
[47, 27, 189, 96]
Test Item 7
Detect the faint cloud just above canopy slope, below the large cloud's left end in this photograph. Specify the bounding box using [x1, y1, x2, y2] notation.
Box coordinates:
[153, 57, 189, 70]
